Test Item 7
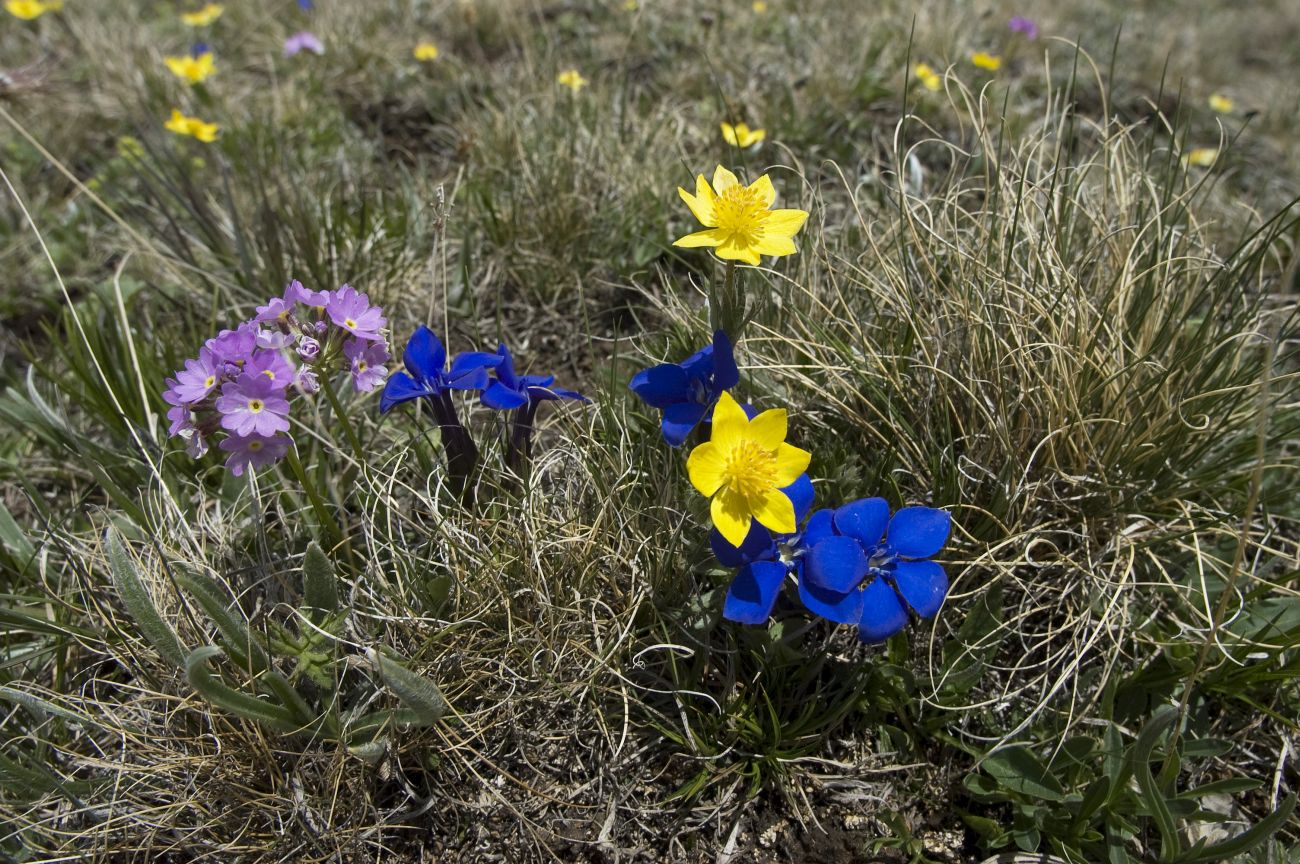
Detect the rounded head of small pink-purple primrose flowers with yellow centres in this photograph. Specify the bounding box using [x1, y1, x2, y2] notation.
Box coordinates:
[163, 279, 389, 477]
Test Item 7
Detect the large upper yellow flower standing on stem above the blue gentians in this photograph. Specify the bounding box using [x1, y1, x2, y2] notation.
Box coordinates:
[673, 165, 809, 264]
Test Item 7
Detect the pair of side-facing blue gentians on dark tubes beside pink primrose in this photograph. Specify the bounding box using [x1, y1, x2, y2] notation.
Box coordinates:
[380, 326, 590, 503]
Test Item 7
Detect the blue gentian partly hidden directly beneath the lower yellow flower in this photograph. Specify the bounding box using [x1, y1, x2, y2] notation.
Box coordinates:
[709, 474, 814, 624]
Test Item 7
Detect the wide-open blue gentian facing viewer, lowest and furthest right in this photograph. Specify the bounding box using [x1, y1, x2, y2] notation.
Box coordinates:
[800, 498, 952, 642]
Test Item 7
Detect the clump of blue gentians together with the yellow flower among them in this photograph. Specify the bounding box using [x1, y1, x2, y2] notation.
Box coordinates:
[629, 330, 950, 642]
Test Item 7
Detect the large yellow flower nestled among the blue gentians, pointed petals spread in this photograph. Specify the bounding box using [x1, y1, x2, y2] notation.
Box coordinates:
[686, 392, 813, 546]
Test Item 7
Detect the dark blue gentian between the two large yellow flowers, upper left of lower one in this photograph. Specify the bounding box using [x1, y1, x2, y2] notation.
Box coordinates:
[628, 330, 740, 447]
